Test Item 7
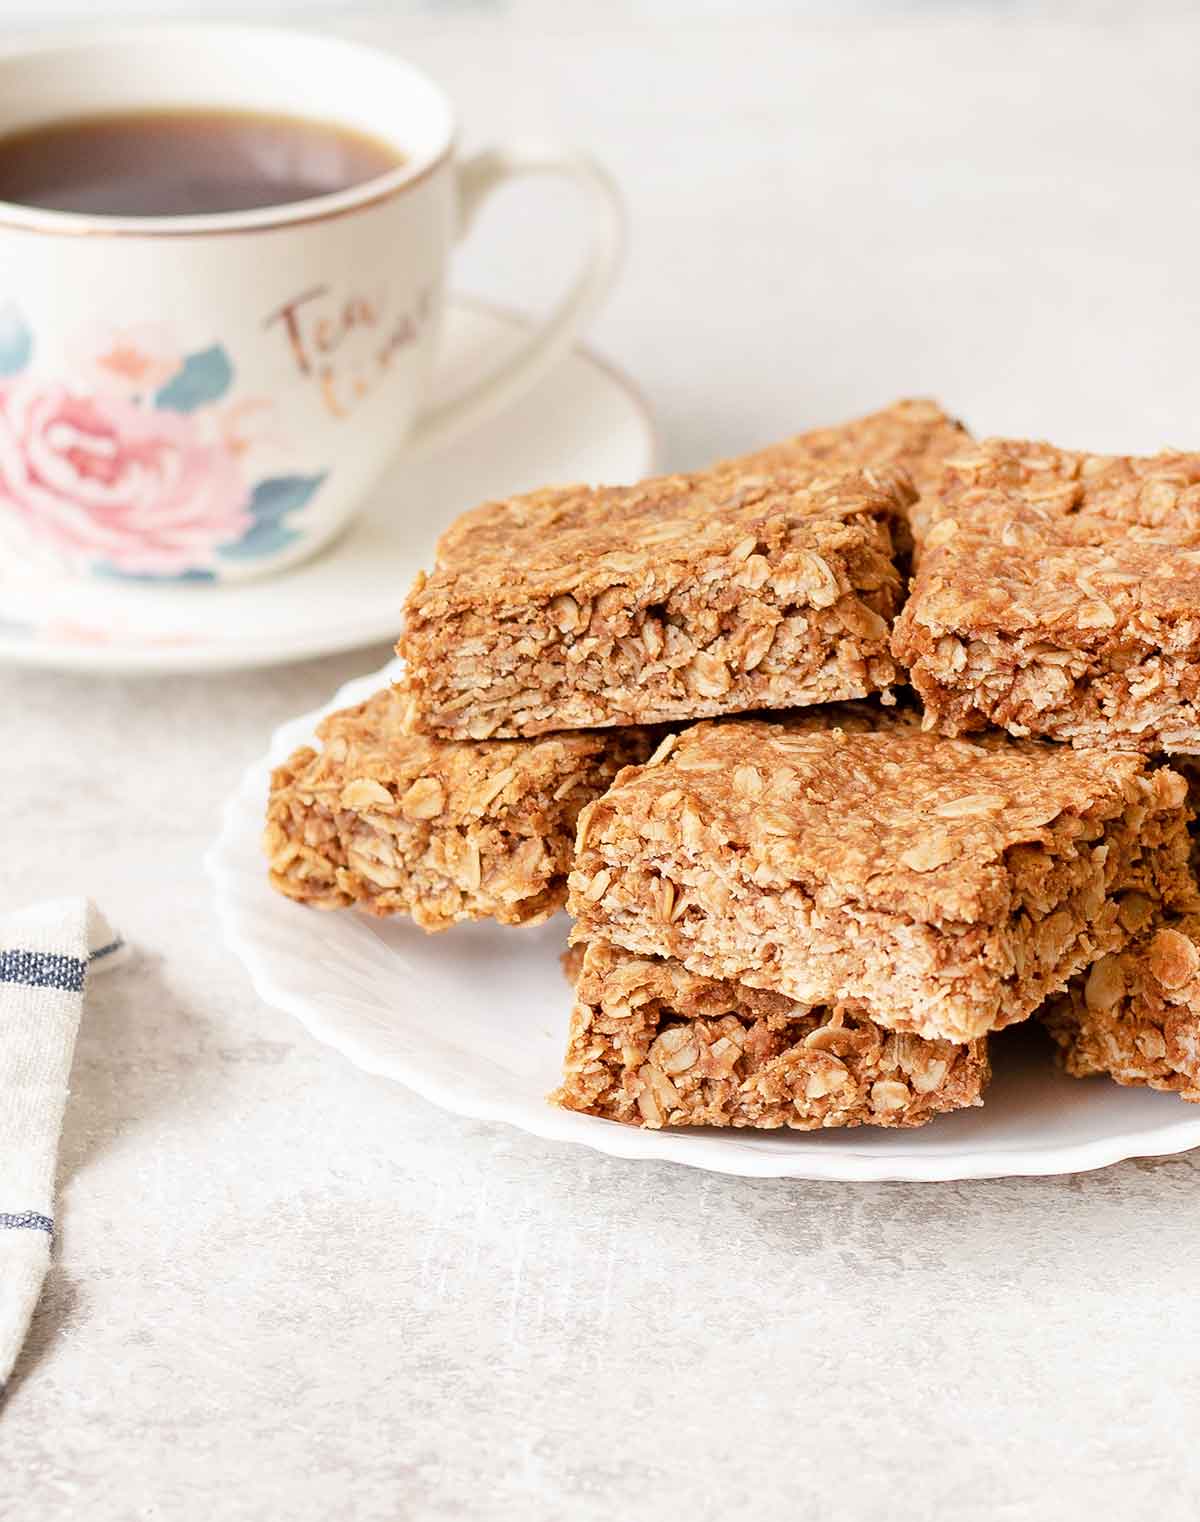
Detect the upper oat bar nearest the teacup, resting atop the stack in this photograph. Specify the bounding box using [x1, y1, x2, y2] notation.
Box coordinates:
[396, 467, 912, 740]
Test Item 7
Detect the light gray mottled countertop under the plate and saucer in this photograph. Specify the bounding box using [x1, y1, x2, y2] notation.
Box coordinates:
[0, 3, 1200, 1522]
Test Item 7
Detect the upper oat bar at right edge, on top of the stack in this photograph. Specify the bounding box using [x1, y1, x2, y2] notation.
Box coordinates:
[892, 441, 1200, 752]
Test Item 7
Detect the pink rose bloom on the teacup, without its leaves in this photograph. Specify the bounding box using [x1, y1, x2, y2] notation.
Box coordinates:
[0, 379, 253, 575]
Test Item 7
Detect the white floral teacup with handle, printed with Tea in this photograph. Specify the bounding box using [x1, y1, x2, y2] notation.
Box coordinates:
[0, 26, 621, 581]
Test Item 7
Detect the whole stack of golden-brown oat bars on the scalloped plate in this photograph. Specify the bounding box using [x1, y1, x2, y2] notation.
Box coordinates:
[266, 402, 1200, 1129]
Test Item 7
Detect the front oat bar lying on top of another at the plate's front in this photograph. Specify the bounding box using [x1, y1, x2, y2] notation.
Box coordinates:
[568, 720, 1188, 1041]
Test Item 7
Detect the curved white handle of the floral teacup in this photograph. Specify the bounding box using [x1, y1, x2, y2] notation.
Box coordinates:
[405, 142, 624, 451]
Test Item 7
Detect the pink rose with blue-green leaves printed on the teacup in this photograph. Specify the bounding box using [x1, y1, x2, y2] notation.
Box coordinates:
[0, 306, 324, 580]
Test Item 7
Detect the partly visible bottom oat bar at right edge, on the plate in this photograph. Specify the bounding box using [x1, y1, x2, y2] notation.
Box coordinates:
[1040, 912, 1200, 1103]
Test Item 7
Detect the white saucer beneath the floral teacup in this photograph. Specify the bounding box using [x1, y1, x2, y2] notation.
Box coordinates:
[0, 300, 655, 673]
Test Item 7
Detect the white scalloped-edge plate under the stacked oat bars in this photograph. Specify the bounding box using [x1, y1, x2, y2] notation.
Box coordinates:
[206, 662, 1200, 1180]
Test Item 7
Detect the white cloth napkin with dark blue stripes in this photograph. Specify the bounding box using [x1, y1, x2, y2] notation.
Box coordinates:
[0, 898, 123, 1394]
